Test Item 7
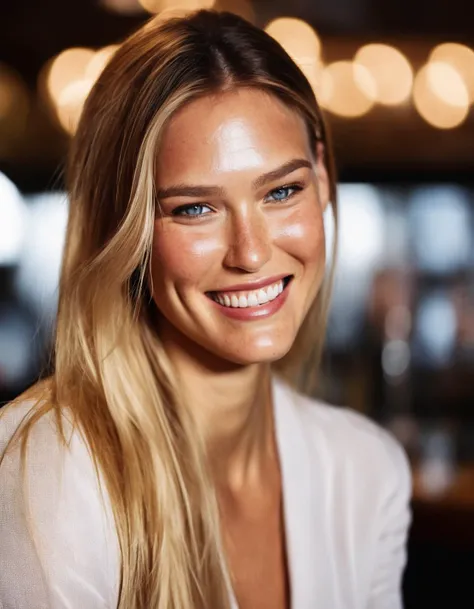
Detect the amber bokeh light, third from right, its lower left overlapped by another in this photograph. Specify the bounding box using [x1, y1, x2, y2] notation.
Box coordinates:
[354, 44, 413, 106]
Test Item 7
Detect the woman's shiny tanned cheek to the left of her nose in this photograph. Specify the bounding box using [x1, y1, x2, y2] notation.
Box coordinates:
[151, 221, 222, 286]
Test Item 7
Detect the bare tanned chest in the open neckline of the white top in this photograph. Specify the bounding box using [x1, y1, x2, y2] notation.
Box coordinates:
[222, 486, 290, 609]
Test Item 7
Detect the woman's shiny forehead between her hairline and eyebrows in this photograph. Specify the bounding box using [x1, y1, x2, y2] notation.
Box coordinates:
[157, 89, 311, 182]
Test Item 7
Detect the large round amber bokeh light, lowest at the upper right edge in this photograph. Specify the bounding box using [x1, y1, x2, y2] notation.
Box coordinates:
[413, 62, 469, 129]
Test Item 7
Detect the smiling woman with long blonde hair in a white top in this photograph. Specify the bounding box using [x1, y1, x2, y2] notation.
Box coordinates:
[0, 11, 410, 609]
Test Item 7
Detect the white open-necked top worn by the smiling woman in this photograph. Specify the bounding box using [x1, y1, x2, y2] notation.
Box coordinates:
[0, 381, 411, 609]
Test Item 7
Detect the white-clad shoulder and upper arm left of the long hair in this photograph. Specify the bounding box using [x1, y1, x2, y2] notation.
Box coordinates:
[0, 394, 119, 607]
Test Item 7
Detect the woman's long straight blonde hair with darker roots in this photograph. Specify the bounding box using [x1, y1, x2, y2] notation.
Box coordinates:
[1, 11, 337, 609]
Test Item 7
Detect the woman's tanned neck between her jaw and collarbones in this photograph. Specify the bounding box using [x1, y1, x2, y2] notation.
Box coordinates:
[161, 324, 277, 492]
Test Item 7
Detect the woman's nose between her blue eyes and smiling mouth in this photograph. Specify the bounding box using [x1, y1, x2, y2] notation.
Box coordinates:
[224, 208, 272, 273]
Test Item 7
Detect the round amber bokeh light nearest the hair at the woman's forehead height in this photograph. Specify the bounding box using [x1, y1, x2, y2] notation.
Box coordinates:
[320, 61, 376, 118]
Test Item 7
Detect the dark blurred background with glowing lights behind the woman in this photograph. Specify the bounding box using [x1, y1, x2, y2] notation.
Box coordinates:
[0, 0, 474, 609]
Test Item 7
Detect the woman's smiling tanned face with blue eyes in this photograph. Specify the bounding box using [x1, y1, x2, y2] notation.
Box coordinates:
[152, 89, 329, 364]
